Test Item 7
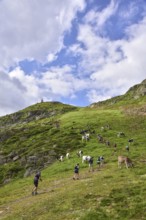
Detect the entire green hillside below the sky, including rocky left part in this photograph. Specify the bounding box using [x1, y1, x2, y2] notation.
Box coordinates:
[0, 83, 146, 220]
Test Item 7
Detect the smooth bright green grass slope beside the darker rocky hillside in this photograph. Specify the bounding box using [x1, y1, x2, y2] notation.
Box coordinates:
[0, 105, 146, 220]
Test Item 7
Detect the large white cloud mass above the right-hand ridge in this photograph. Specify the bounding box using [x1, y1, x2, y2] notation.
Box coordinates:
[71, 13, 146, 101]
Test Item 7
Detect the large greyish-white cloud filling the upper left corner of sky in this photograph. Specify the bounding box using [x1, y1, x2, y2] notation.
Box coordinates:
[0, 0, 85, 68]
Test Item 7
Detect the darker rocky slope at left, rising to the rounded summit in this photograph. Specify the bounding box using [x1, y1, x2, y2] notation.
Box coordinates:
[0, 102, 79, 183]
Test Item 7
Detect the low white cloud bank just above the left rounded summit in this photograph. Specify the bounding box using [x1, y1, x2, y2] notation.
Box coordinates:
[0, 65, 89, 115]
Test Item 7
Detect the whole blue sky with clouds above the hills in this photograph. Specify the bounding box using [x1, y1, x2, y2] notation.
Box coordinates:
[0, 0, 146, 116]
